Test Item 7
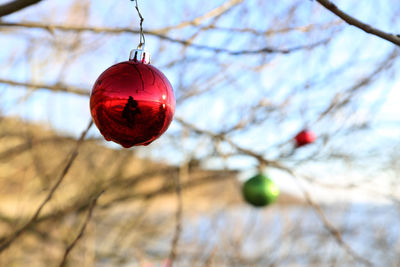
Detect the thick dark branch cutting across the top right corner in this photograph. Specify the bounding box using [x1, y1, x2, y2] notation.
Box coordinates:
[317, 0, 400, 46]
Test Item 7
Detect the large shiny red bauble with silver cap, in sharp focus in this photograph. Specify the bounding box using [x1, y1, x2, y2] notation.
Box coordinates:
[90, 49, 175, 148]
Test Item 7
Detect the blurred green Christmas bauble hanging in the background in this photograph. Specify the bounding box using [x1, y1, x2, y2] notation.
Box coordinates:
[242, 173, 279, 207]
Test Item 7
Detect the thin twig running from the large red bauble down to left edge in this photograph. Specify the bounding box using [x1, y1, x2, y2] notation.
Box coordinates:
[0, 120, 93, 253]
